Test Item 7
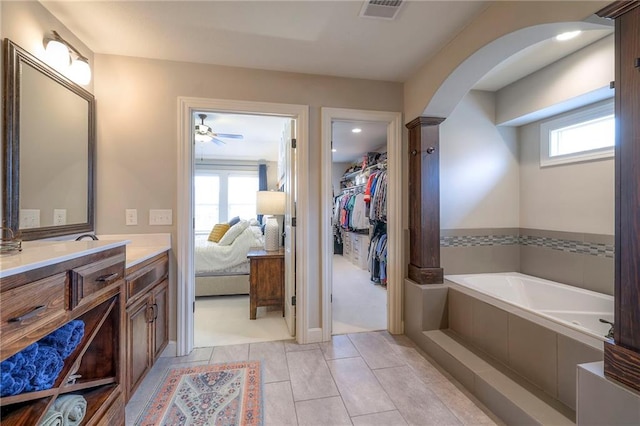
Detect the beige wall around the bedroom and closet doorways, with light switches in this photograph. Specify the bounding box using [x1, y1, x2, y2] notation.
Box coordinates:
[95, 51, 403, 338]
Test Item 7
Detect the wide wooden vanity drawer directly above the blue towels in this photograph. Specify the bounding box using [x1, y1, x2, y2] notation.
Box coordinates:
[0, 273, 67, 352]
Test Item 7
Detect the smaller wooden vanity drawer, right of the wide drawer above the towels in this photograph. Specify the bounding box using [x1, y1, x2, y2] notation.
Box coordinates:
[71, 254, 125, 308]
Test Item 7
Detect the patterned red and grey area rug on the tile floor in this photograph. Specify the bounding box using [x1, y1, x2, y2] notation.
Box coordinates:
[137, 361, 263, 426]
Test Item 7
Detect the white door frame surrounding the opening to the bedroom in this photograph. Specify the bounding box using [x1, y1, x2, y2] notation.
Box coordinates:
[179, 96, 312, 356]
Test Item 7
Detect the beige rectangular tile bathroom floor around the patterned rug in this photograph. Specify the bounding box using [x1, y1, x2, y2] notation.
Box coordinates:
[126, 331, 501, 426]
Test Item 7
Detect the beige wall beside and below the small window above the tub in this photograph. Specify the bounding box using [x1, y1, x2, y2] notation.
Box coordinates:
[518, 101, 615, 235]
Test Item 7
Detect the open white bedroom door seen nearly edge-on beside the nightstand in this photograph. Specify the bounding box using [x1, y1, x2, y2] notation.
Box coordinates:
[282, 120, 297, 336]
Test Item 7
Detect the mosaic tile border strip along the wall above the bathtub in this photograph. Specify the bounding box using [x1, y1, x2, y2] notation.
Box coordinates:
[440, 235, 615, 259]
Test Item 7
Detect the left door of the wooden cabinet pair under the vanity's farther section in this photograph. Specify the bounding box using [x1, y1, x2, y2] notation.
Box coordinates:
[127, 297, 153, 399]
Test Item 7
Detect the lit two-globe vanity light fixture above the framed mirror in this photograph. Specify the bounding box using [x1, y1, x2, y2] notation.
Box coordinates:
[44, 30, 91, 85]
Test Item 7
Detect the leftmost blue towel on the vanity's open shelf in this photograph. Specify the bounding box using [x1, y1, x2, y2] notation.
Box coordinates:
[0, 343, 38, 397]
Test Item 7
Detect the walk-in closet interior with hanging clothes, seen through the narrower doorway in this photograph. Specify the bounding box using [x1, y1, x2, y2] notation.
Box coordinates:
[331, 121, 387, 334]
